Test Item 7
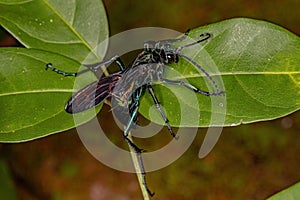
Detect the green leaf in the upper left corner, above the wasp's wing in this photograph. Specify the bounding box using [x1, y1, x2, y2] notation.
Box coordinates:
[0, 0, 108, 63]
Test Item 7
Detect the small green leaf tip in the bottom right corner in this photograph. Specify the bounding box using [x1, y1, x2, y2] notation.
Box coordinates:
[268, 183, 300, 200]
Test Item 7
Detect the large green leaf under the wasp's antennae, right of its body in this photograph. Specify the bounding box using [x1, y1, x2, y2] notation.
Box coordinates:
[140, 19, 300, 127]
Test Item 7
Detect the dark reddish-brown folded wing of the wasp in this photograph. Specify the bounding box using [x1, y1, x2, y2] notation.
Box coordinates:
[65, 74, 121, 113]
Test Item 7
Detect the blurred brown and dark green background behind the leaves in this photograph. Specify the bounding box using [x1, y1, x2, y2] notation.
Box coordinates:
[0, 0, 300, 200]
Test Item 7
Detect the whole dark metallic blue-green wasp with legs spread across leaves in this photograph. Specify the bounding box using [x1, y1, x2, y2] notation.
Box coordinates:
[46, 30, 225, 196]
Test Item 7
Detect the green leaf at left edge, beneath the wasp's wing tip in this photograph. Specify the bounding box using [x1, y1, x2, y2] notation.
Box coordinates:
[0, 48, 100, 142]
